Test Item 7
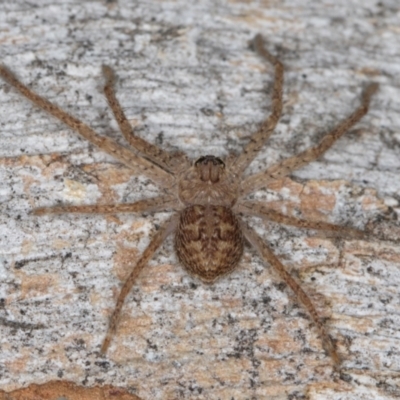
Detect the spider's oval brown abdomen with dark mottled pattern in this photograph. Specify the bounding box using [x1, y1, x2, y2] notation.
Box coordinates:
[175, 205, 243, 283]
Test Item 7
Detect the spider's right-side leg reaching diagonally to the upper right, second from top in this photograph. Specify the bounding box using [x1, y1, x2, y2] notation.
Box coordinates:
[241, 83, 378, 196]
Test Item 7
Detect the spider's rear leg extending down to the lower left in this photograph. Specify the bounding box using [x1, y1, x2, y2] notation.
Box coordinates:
[101, 214, 179, 354]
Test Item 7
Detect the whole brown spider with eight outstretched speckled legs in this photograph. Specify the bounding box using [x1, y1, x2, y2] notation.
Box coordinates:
[0, 35, 378, 367]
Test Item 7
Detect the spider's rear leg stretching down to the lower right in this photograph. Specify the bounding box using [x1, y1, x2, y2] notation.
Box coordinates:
[242, 223, 341, 369]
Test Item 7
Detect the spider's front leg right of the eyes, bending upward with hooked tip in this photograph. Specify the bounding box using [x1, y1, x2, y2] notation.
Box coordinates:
[233, 35, 283, 176]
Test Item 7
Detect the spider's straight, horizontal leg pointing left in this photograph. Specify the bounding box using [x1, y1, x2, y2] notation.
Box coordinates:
[33, 196, 179, 215]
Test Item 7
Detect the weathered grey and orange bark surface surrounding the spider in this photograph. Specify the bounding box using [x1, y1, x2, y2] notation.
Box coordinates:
[0, 0, 400, 400]
